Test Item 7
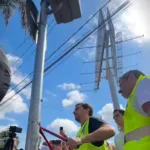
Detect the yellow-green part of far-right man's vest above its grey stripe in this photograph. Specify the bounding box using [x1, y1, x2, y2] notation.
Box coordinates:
[124, 76, 150, 135]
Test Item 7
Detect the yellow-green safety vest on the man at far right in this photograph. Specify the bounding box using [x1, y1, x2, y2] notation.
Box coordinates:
[124, 76, 150, 150]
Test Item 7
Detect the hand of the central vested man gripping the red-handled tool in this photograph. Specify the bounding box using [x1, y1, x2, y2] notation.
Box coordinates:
[67, 138, 82, 148]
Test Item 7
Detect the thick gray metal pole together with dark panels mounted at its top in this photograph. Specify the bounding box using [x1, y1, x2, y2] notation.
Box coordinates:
[25, 0, 81, 150]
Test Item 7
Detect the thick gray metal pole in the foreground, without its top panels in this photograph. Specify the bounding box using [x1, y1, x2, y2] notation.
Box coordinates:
[25, 0, 48, 150]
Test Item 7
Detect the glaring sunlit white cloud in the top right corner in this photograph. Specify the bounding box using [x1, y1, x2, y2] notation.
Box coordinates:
[109, 0, 150, 41]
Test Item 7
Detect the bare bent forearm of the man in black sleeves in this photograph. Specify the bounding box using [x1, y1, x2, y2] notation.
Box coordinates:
[81, 124, 115, 143]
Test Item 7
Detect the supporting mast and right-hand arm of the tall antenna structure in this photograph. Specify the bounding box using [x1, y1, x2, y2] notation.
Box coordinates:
[106, 8, 120, 109]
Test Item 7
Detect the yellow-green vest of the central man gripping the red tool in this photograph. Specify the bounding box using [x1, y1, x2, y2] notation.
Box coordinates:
[77, 119, 106, 150]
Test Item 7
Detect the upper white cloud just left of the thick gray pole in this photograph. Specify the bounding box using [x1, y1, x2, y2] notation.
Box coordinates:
[7, 54, 31, 99]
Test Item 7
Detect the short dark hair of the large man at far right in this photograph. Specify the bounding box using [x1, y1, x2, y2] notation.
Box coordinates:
[119, 70, 145, 80]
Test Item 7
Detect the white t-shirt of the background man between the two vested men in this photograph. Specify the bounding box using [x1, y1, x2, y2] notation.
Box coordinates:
[115, 131, 124, 150]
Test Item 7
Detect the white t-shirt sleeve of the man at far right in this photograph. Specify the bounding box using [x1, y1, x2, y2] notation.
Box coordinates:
[133, 78, 150, 116]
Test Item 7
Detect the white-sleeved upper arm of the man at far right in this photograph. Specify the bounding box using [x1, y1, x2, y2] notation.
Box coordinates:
[136, 78, 150, 117]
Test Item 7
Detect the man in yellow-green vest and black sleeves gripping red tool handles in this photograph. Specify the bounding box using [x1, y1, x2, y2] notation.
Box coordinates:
[67, 103, 115, 150]
